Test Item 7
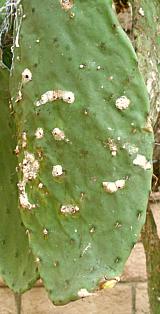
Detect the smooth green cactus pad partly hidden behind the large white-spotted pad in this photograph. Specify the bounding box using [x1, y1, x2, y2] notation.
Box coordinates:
[0, 65, 37, 293]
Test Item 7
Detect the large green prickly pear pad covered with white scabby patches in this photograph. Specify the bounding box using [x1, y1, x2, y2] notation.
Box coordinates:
[10, 0, 153, 305]
